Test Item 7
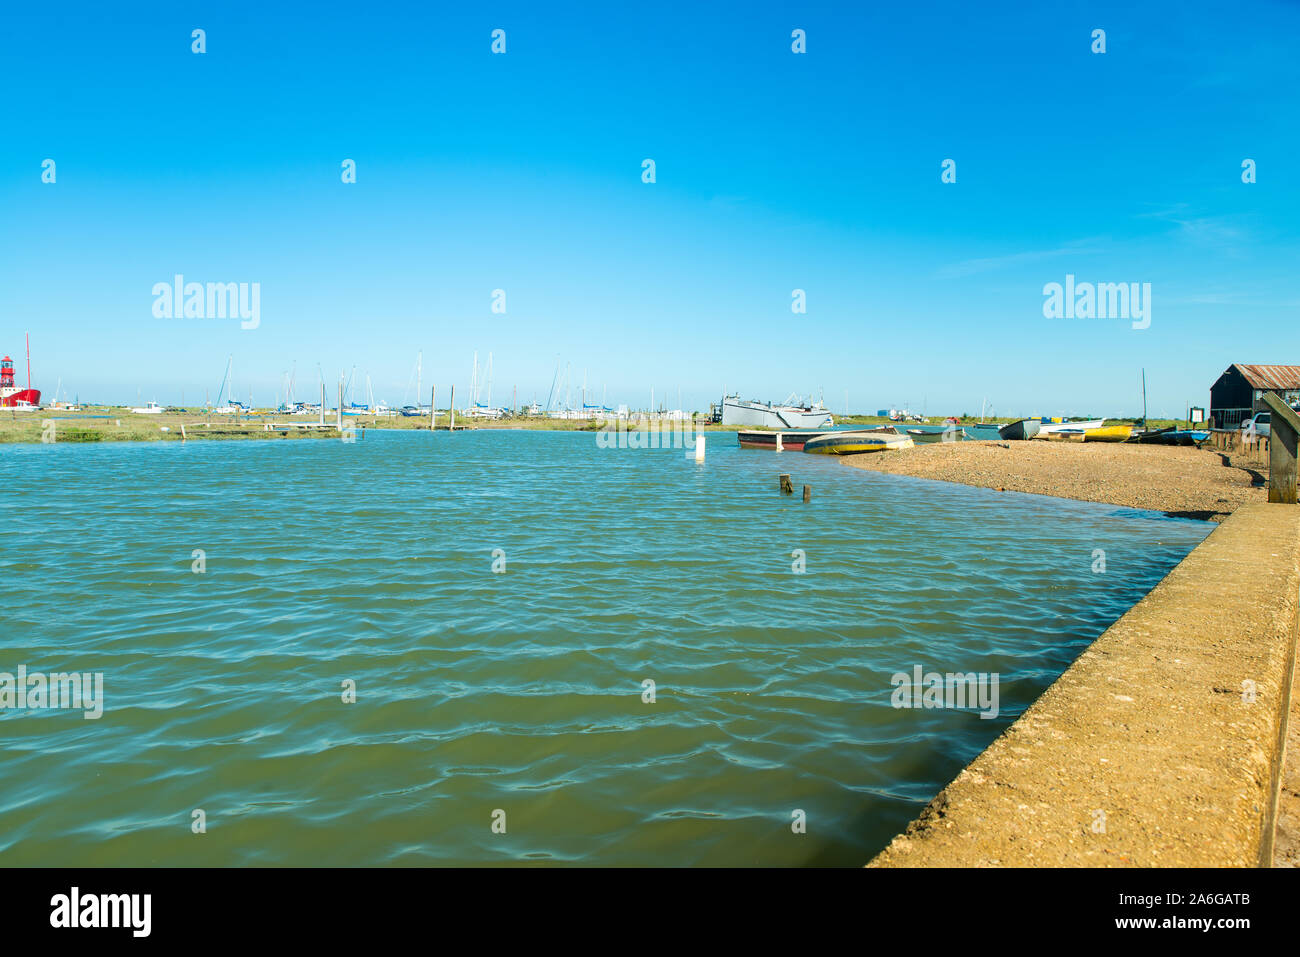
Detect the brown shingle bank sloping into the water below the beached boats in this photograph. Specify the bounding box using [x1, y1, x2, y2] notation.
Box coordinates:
[845, 442, 1268, 521]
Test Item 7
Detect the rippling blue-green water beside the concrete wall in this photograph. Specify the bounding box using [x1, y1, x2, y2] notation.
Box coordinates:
[0, 432, 1209, 865]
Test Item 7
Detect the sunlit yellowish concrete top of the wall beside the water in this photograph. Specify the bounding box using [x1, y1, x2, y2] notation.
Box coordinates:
[870, 505, 1300, 867]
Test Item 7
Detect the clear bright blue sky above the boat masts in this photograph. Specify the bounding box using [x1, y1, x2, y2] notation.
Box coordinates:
[0, 1, 1300, 415]
